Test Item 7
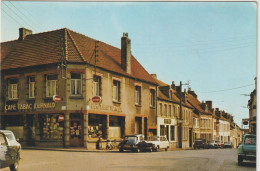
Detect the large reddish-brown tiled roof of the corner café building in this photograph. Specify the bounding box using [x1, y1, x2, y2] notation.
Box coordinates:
[1, 28, 156, 84]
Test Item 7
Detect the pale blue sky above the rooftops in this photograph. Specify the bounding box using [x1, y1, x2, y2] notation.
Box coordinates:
[1, 1, 257, 126]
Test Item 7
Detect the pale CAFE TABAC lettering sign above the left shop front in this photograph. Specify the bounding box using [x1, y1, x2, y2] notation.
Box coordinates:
[4, 102, 55, 112]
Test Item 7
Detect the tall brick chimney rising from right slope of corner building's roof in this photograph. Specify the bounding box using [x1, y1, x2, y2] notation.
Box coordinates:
[121, 33, 131, 74]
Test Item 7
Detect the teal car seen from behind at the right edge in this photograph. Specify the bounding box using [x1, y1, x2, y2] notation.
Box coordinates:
[238, 134, 256, 165]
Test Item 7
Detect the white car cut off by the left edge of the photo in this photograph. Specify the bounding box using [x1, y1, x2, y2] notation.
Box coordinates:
[0, 130, 21, 171]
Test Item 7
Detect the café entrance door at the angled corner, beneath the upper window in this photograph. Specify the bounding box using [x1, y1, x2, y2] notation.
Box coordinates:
[70, 114, 83, 147]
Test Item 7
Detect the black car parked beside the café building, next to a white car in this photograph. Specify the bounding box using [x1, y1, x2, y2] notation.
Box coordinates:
[118, 134, 150, 152]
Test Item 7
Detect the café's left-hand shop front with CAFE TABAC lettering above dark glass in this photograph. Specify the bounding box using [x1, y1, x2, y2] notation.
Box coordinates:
[1, 102, 64, 147]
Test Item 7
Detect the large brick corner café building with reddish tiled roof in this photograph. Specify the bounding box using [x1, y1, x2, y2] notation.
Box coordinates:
[0, 28, 157, 147]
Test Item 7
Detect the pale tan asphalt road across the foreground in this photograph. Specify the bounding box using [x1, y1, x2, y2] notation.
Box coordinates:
[0, 149, 256, 171]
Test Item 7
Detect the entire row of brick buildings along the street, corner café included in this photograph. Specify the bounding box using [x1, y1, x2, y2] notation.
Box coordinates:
[0, 28, 242, 148]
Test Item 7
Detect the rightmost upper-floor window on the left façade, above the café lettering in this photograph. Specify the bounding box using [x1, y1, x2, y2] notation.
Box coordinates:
[46, 75, 58, 97]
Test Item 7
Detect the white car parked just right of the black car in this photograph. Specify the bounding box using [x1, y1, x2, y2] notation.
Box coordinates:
[147, 136, 170, 151]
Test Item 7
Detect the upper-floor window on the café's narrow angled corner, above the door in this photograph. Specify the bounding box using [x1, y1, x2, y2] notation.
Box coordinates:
[70, 73, 81, 95]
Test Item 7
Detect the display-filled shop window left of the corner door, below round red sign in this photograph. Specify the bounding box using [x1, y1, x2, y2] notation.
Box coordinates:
[38, 114, 64, 140]
